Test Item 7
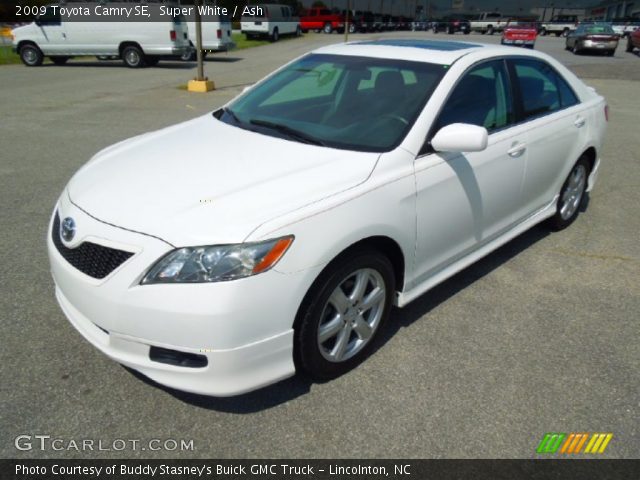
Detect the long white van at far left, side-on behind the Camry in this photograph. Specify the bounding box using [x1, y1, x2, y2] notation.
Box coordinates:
[13, 2, 189, 68]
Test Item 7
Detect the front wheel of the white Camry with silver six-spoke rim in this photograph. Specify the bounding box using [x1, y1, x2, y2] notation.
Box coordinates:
[294, 249, 395, 381]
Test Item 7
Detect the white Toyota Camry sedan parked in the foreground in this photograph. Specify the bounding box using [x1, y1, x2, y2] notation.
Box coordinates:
[48, 40, 608, 396]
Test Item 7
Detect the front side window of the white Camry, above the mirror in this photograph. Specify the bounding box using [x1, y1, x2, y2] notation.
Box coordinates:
[434, 60, 514, 132]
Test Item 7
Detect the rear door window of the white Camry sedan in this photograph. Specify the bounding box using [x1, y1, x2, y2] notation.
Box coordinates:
[514, 59, 578, 120]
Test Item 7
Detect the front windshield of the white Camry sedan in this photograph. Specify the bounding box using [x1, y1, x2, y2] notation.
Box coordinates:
[220, 54, 446, 152]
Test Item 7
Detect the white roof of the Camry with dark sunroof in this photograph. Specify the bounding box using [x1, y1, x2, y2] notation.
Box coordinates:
[314, 39, 488, 65]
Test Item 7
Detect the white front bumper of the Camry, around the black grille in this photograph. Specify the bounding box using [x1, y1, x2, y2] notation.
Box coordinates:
[47, 194, 319, 396]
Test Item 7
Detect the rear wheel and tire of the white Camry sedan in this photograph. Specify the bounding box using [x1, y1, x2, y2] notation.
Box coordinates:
[550, 155, 589, 230]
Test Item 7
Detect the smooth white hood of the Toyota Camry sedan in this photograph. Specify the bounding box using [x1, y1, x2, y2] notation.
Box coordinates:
[68, 115, 379, 246]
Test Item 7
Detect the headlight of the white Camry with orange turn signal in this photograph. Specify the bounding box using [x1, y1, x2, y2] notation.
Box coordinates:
[140, 236, 293, 285]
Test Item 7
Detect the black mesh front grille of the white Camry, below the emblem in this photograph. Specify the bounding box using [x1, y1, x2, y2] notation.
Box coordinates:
[51, 213, 133, 278]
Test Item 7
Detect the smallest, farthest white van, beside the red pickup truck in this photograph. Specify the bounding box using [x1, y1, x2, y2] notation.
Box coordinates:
[240, 4, 302, 42]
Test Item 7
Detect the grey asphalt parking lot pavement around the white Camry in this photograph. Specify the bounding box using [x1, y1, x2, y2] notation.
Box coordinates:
[0, 34, 640, 458]
